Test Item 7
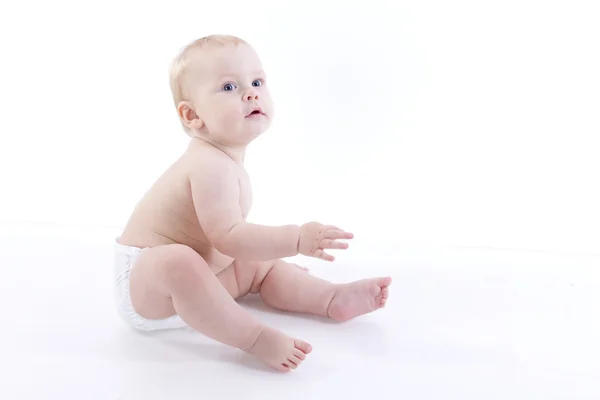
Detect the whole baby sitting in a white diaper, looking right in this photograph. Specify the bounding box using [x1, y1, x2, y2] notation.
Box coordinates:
[115, 35, 391, 371]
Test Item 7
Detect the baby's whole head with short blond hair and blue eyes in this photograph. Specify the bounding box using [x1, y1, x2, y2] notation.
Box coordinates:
[171, 35, 273, 147]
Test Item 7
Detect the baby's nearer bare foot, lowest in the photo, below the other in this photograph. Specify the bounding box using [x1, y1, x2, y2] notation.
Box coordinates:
[249, 327, 312, 372]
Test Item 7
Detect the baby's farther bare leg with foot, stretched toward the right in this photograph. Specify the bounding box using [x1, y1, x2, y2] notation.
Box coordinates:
[255, 260, 392, 322]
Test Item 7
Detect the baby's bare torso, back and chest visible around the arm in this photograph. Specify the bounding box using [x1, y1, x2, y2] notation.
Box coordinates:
[119, 148, 252, 273]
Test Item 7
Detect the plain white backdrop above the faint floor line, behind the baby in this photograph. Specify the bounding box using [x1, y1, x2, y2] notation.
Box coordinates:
[0, 0, 600, 253]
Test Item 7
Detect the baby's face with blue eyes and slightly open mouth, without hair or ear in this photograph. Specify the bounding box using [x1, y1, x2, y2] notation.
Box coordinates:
[189, 44, 273, 146]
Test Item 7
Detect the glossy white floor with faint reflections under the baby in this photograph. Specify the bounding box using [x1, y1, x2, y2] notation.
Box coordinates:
[0, 226, 600, 400]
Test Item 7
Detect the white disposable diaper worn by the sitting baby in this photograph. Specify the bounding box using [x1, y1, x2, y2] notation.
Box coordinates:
[114, 238, 187, 332]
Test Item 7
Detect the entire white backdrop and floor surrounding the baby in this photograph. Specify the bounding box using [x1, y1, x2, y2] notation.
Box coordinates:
[0, 0, 600, 400]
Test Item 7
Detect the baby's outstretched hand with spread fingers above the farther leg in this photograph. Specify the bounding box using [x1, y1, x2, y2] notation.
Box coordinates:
[298, 222, 354, 261]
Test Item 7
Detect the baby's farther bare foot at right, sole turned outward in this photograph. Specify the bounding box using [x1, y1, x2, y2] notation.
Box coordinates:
[327, 277, 392, 322]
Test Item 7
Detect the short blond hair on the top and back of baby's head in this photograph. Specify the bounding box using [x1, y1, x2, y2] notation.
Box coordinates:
[169, 35, 247, 133]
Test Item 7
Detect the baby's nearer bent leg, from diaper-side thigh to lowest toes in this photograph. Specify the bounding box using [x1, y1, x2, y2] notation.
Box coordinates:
[130, 244, 311, 371]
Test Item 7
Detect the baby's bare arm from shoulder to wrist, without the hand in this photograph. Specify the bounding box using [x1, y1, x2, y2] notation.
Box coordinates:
[190, 159, 300, 261]
